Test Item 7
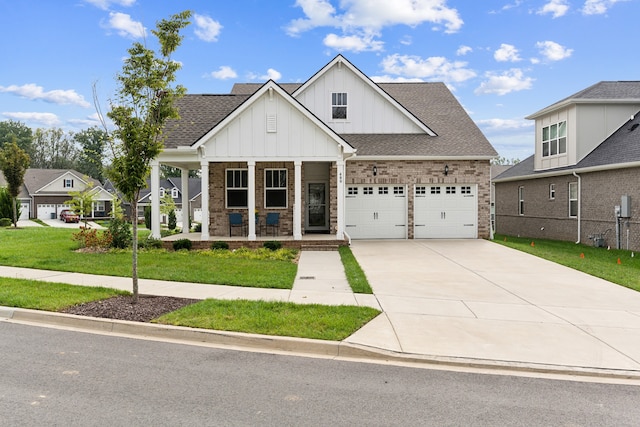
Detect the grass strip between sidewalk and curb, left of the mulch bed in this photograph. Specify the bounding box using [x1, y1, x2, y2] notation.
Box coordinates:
[0, 277, 129, 311]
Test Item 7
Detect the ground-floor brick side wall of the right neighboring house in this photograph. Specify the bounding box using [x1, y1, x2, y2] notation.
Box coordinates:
[495, 168, 640, 250]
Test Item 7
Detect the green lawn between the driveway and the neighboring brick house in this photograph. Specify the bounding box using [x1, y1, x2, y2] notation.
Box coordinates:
[494, 235, 640, 291]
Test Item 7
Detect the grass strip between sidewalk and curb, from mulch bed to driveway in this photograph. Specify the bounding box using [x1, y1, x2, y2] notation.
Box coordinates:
[154, 299, 380, 341]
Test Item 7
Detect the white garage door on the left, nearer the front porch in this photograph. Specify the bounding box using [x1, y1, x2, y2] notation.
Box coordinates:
[345, 185, 407, 239]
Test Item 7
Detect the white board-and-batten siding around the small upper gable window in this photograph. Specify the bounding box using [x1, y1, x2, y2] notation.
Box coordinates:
[295, 65, 424, 134]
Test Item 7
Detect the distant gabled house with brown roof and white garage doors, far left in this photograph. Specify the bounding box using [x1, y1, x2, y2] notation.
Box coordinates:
[0, 169, 113, 219]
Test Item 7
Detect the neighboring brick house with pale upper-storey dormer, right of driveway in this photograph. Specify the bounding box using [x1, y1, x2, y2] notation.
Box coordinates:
[494, 81, 640, 250]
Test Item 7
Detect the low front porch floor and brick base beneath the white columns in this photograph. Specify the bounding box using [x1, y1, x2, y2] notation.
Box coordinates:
[161, 233, 349, 251]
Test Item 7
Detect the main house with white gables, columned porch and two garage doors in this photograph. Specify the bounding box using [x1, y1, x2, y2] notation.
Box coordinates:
[151, 55, 497, 240]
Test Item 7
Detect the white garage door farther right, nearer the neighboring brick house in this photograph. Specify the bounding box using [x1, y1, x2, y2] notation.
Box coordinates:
[414, 184, 478, 239]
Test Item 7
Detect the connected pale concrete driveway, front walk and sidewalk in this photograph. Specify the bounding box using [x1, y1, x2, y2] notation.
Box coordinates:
[0, 240, 640, 379]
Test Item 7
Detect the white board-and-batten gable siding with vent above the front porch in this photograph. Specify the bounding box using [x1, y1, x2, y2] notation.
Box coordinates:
[205, 91, 340, 159]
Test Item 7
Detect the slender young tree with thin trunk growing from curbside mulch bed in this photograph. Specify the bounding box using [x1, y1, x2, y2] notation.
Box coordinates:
[107, 11, 191, 303]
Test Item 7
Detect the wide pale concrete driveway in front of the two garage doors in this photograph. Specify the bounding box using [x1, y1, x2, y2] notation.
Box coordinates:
[347, 240, 640, 371]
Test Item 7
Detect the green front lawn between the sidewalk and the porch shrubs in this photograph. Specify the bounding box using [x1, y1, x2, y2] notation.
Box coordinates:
[0, 227, 297, 289]
